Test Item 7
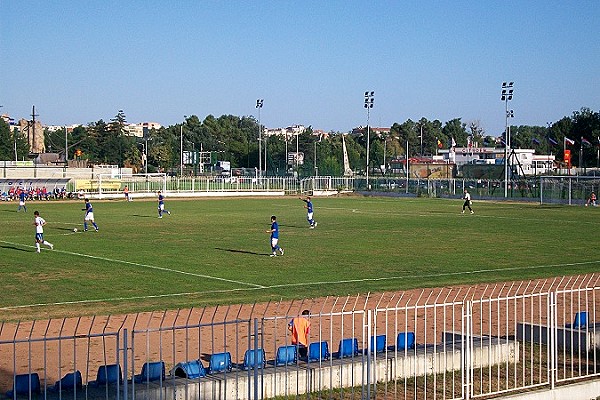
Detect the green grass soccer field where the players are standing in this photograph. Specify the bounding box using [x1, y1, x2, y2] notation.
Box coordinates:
[0, 196, 600, 320]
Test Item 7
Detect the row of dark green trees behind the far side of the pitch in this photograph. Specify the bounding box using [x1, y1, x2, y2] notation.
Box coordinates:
[0, 108, 600, 176]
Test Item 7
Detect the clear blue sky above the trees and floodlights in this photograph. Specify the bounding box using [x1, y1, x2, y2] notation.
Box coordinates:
[0, 0, 600, 136]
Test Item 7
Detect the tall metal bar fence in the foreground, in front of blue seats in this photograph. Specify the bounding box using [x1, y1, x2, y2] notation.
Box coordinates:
[0, 274, 600, 399]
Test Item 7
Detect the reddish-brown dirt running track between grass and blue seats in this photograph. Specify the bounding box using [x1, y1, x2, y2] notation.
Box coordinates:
[0, 274, 600, 392]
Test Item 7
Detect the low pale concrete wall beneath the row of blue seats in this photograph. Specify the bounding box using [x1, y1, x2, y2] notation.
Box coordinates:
[118, 338, 520, 400]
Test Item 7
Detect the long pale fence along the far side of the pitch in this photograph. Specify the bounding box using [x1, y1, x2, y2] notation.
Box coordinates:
[0, 173, 600, 205]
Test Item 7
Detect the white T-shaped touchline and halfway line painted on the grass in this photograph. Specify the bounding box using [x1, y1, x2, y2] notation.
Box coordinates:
[0, 240, 600, 310]
